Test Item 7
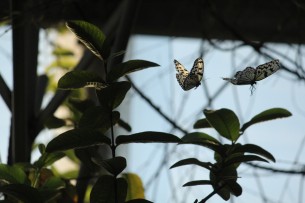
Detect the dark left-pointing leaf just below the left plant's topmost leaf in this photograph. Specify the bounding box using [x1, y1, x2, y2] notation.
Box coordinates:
[58, 70, 107, 90]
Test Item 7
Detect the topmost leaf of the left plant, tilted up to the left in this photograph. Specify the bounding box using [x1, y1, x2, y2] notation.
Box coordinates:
[66, 20, 106, 60]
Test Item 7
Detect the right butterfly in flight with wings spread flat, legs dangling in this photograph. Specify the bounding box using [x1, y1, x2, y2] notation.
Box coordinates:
[222, 59, 281, 93]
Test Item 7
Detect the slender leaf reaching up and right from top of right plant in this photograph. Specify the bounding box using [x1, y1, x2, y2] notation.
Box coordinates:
[240, 108, 292, 132]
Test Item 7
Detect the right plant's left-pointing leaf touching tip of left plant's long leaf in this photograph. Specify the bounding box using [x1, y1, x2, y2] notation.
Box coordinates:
[179, 132, 222, 153]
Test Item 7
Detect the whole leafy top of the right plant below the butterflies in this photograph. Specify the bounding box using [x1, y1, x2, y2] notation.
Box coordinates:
[171, 108, 291, 202]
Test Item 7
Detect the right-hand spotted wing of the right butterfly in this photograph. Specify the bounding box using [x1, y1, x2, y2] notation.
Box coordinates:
[255, 60, 280, 81]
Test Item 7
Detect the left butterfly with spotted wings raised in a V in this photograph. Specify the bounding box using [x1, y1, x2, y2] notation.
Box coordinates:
[174, 58, 204, 91]
